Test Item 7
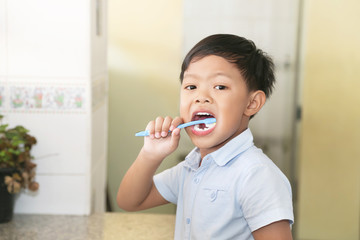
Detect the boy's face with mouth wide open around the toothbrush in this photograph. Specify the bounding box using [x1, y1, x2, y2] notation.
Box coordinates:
[180, 55, 251, 157]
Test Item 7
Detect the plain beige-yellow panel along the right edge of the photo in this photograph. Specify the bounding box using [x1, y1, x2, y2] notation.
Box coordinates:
[297, 0, 360, 240]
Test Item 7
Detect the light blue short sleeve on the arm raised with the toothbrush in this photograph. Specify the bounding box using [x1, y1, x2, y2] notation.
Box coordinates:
[154, 163, 184, 204]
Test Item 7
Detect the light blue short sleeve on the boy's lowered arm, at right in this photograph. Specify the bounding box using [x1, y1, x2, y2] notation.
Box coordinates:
[240, 164, 294, 232]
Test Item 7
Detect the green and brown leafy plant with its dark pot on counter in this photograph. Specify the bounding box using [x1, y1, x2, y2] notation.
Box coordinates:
[0, 115, 39, 223]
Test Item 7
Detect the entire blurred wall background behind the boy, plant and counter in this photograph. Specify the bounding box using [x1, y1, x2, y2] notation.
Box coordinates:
[0, 0, 360, 240]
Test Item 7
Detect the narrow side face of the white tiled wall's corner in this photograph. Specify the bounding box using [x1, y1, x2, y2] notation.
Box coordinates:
[89, 0, 109, 212]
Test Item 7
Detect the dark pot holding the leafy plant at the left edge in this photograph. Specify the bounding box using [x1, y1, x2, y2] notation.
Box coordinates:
[0, 168, 15, 223]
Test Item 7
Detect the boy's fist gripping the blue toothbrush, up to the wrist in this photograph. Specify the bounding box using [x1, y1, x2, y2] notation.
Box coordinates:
[142, 117, 183, 161]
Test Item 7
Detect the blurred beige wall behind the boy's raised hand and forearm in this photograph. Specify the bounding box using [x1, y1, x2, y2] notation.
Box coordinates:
[108, 0, 182, 213]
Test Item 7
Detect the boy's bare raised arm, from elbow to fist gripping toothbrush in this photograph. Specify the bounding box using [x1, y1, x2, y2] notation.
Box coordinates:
[116, 117, 183, 211]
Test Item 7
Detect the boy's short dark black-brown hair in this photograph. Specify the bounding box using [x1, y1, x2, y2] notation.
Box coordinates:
[180, 34, 275, 98]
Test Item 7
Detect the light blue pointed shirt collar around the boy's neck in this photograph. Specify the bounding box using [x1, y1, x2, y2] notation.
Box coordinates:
[185, 128, 254, 170]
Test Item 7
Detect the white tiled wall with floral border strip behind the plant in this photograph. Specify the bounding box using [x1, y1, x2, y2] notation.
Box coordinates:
[0, 0, 107, 214]
